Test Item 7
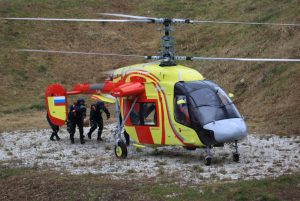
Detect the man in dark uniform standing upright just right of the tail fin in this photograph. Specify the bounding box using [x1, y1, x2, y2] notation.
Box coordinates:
[69, 98, 86, 144]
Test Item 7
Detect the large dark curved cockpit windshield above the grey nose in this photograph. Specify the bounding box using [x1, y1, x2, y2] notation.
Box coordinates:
[175, 80, 241, 126]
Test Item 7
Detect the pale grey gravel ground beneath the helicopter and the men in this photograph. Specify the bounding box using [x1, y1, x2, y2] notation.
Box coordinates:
[0, 124, 300, 183]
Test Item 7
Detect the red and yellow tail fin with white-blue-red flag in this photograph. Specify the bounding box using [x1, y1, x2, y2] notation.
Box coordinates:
[45, 84, 68, 126]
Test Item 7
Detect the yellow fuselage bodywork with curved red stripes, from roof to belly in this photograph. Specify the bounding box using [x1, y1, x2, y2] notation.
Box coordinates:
[113, 64, 204, 146]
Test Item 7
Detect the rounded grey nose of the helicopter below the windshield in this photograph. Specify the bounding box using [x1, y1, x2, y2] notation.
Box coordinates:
[203, 118, 248, 143]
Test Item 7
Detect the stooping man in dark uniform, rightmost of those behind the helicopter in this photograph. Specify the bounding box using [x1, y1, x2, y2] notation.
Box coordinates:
[88, 101, 110, 141]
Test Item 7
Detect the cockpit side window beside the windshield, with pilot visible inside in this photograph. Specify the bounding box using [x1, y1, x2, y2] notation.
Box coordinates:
[174, 95, 191, 126]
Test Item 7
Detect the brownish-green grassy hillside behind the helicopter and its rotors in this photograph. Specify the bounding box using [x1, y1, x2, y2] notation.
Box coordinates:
[0, 0, 300, 135]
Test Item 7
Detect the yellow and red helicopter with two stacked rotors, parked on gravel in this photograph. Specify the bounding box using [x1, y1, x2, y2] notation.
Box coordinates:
[5, 13, 300, 165]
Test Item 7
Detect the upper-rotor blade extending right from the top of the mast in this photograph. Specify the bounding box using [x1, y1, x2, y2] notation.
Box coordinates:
[189, 20, 300, 26]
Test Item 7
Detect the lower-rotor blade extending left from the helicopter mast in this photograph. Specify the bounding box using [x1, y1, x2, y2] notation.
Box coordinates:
[16, 49, 145, 58]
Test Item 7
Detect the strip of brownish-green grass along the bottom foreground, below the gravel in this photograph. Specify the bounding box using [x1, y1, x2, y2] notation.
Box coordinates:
[0, 167, 300, 201]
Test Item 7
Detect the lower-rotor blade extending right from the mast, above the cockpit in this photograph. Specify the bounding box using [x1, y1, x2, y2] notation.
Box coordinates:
[175, 56, 300, 62]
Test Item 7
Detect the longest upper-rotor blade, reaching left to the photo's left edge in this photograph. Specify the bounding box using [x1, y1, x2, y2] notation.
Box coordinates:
[4, 17, 153, 23]
